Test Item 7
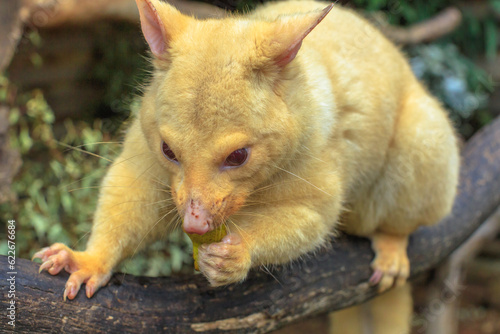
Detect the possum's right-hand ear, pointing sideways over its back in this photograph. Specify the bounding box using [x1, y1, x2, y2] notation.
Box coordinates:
[260, 4, 334, 67]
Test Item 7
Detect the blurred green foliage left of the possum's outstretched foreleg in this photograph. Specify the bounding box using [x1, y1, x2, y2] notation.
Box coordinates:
[0, 78, 108, 257]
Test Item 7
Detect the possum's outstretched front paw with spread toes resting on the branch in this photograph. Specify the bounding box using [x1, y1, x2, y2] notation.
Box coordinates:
[32, 243, 111, 300]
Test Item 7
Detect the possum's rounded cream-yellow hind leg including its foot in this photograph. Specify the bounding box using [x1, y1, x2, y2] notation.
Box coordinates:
[364, 86, 459, 290]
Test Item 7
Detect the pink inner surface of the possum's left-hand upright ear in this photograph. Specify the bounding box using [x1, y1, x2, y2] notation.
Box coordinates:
[138, 0, 167, 57]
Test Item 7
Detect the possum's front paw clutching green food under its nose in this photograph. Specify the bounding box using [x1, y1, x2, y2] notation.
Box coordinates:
[198, 234, 251, 286]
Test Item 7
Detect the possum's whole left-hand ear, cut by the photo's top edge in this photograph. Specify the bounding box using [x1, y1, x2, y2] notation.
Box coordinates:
[135, 0, 190, 58]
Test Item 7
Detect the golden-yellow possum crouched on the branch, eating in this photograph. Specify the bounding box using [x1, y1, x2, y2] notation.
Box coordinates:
[35, 0, 459, 332]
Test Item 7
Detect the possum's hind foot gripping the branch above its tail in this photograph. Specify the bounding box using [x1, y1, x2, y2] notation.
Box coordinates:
[370, 233, 410, 292]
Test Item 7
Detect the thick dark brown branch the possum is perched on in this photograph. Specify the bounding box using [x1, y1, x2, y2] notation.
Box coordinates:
[0, 119, 500, 333]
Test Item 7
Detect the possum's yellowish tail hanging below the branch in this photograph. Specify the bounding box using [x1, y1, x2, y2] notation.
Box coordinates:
[329, 284, 413, 334]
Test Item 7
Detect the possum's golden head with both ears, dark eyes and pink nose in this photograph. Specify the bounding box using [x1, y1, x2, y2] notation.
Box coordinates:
[136, 0, 330, 234]
